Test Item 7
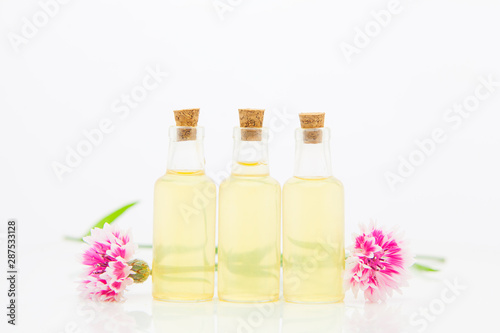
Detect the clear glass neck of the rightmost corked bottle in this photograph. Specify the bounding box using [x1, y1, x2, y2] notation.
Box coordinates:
[294, 128, 332, 178]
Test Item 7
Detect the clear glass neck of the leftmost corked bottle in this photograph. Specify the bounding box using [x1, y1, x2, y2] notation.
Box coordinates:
[167, 126, 205, 173]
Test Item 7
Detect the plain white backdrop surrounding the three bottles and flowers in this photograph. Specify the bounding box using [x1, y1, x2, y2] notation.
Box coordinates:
[0, 0, 500, 332]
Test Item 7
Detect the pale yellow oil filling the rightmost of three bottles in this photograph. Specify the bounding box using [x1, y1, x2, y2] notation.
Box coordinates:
[283, 177, 345, 303]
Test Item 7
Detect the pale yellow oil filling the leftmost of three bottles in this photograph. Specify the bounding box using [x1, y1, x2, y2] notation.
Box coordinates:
[152, 171, 216, 301]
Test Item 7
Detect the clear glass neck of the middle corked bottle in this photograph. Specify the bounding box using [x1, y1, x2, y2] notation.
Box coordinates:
[231, 127, 269, 176]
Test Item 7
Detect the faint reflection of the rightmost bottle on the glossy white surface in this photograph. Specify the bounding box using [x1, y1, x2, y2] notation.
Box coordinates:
[283, 303, 345, 333]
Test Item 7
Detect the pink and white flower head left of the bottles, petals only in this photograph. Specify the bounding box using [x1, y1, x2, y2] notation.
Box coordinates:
[80, 223, 137, 302]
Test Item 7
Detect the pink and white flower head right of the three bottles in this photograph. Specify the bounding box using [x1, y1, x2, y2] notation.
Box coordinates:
[345, 222, 414, 302]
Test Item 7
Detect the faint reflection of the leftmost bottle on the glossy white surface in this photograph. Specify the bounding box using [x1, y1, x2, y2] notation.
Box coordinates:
[153, 301, 215, 333]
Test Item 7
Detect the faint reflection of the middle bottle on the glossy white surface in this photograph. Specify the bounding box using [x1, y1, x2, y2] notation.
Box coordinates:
[217, 301, 281, 333]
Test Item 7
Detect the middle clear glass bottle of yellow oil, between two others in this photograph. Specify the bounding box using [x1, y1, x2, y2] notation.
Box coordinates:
[217, 127, 281, 302]
